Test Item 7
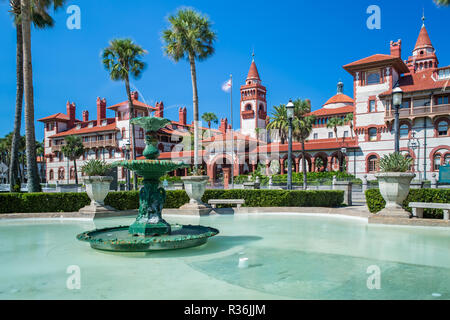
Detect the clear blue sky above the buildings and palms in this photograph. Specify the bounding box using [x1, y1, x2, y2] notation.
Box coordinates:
[0, 0, 450, 140]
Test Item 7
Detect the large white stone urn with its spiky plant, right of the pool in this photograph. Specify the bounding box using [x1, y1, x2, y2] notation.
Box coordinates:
[375, 152, 416, 218]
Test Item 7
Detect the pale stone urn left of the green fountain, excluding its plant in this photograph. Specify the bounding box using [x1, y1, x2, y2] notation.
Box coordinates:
[79, 176, 116, 215]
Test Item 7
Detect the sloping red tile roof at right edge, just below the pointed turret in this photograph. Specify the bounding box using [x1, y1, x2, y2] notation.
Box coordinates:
[380, 69, 449, 96]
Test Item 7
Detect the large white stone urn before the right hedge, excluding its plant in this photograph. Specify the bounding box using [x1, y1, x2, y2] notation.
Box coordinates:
[375, 172, 416, 218]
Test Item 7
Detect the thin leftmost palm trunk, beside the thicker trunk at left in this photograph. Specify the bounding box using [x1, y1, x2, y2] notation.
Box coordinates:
[9, 24, 23, 192]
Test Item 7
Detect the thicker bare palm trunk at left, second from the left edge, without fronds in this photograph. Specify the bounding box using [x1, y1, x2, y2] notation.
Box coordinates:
[20, 0, 41, 192]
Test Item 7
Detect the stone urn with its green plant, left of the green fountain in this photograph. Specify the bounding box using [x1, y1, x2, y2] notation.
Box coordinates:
[80, 159, 115, 213]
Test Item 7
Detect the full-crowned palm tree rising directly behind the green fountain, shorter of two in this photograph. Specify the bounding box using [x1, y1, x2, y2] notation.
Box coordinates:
[103, 39, 147, 189]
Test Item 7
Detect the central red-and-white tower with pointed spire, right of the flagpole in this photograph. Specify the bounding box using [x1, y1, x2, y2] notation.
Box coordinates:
[240, 59, 267, 138]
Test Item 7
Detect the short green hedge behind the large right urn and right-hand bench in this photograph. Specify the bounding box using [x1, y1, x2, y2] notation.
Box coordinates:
[366, 189, 450, 219]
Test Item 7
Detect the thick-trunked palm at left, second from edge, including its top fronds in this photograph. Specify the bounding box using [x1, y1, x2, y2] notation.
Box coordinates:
[20, 0, 64, 192]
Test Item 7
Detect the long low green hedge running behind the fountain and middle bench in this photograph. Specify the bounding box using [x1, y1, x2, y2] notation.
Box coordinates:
[0, 190, 344, 213]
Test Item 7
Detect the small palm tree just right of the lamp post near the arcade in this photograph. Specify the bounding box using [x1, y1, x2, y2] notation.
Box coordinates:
[292, 99, 316, 190]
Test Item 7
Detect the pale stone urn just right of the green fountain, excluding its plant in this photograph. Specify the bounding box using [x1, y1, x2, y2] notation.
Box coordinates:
[180, 176, 211, 216]
